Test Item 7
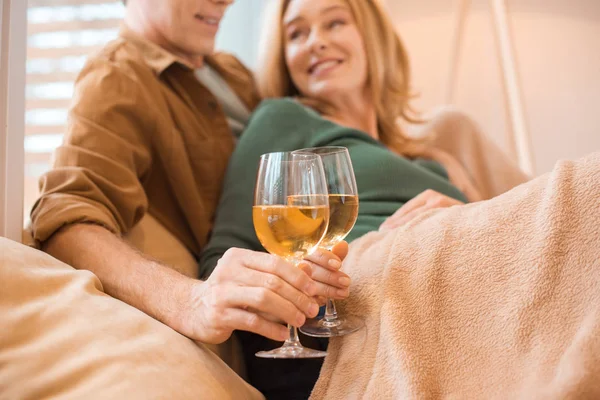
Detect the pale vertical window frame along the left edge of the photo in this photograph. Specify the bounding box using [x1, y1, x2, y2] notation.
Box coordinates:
[0, 0, 27, 242]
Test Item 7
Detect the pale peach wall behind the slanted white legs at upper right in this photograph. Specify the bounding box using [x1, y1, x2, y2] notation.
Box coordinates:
[387, 0, 600, 173]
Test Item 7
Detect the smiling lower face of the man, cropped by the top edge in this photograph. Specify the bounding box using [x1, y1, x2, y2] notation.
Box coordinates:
[138, 0, 233, 58]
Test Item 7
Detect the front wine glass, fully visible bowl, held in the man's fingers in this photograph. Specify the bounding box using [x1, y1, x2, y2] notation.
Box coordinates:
[252, 152, 329, 358]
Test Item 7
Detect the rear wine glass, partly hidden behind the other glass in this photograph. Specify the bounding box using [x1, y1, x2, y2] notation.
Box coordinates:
[294, 146, 365, 337]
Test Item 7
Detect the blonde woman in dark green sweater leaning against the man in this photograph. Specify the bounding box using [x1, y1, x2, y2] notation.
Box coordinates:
[200, 0, 478, 398]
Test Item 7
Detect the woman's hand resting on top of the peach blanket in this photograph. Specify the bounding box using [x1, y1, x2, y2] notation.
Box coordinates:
[379, 189, 464, 231]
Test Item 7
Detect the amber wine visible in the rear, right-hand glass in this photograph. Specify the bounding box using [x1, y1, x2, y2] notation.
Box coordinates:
[320, 194, 358, 249]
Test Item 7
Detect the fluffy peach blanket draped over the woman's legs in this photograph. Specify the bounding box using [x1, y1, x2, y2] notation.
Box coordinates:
[311, 153, 600, 400]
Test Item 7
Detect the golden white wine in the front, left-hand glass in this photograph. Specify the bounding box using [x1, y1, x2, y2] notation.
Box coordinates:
[252, 205, 329, 260]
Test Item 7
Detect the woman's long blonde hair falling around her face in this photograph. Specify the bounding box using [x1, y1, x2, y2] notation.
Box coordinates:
[257, 0, 422, 156]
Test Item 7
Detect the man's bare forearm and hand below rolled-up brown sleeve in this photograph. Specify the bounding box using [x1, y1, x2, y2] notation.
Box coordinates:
[44, 224, 328, 343]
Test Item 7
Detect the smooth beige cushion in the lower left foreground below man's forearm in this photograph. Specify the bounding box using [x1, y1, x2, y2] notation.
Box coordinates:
[0, 238, 262, 399]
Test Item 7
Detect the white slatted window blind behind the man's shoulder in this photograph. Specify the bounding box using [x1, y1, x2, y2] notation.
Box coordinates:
[24, 0, 125, 217]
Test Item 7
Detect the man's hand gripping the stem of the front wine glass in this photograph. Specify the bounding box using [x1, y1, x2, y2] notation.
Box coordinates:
[177, 249, 319, 343]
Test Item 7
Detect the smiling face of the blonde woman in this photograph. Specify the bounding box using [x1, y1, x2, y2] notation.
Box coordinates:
[283, 0, 368, 101]
